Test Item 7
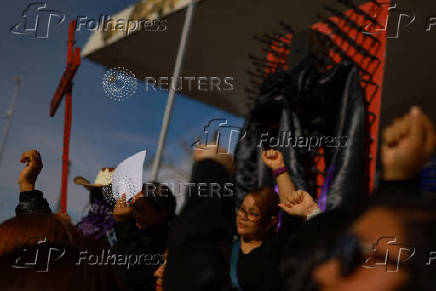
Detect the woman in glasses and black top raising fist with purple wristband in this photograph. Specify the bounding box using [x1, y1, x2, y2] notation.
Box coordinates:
[230, 150, 320, 291]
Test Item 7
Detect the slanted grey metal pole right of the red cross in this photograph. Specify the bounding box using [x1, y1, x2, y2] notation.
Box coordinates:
[151, 0, 195, 181]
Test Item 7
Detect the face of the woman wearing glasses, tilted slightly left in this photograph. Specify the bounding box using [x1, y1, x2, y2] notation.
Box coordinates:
[236, 195, 261, 240]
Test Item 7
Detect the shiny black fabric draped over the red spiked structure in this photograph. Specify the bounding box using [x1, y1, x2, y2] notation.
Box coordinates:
[235, 56, 368, 210]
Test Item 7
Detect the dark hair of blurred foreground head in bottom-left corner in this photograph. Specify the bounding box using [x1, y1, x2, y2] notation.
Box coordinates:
[0, 243, 121, 291]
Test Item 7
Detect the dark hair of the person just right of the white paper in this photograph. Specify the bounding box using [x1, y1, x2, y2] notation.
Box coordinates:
[142, 182, 176, 221]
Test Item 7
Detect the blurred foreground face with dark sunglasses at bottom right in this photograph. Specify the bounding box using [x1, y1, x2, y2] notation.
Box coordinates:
[313, 208, 408, 291]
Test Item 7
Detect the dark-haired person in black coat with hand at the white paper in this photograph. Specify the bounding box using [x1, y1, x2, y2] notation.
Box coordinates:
[113, 183, 176, 290]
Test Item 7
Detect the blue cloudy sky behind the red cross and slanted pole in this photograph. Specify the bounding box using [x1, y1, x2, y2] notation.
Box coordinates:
[0, 0, 244, 222]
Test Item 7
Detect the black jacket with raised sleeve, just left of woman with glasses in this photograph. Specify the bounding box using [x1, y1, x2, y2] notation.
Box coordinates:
[164, 160, 234, 291]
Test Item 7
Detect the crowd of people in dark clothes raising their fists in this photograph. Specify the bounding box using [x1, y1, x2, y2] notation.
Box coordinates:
[0, 107, 436, 291]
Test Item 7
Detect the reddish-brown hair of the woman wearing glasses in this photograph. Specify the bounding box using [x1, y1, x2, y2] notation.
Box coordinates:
[247, 188, 280, 237]
